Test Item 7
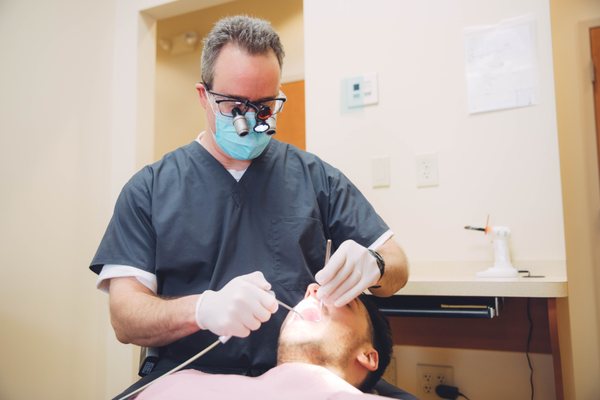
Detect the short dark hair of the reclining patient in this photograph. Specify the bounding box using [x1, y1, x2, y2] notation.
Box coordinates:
[358, 294, 393, 393]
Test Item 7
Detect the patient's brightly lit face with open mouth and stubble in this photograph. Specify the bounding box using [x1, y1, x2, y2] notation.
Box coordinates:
[277, 284, 370, 367]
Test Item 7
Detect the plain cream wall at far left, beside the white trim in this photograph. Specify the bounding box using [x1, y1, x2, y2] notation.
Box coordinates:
[0, 0, 115, 400]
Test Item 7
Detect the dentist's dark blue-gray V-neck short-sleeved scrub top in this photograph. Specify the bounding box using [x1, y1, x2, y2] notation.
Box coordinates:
[90, 139, 388, 376]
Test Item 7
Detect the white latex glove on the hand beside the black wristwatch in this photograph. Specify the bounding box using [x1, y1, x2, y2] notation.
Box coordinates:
[315, 240, 381, 307]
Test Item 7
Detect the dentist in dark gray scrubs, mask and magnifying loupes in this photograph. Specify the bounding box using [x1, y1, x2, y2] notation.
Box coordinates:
[90, 16, 408, 394]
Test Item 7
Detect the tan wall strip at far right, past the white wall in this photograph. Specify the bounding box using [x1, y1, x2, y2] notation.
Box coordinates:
[550, 0, 600, 399]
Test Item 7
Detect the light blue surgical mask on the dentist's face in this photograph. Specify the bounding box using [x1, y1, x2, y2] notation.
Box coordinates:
[215, 112, 271, 160]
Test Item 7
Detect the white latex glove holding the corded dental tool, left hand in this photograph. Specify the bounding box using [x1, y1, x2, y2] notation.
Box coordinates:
[196, 271, 278, 337]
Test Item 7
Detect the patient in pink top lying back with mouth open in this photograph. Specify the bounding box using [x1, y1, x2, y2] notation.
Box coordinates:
[137, 284, 392, 400]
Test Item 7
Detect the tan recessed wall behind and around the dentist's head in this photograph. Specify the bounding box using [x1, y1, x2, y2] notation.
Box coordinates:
[154, 0, 304, 159]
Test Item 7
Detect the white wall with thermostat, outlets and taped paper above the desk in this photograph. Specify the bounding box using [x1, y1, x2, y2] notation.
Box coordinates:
[304, 0, 565, 274]
